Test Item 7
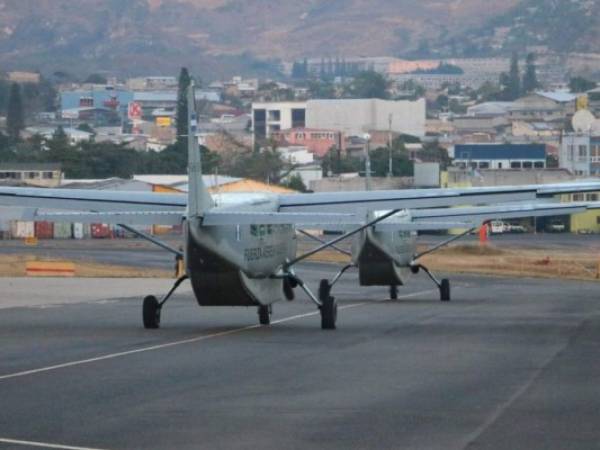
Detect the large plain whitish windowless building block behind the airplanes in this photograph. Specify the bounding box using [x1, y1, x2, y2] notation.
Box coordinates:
[306, 99, 425, 137]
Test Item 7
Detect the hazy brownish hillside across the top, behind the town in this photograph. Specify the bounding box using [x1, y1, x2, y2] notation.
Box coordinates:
[0, 0, 599, 78]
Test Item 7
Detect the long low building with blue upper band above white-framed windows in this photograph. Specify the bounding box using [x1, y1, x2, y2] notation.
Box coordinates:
[454, 144, 546, 170]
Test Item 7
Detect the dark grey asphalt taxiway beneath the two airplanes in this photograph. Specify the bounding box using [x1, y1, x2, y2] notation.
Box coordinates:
[0, 264, 600, 450]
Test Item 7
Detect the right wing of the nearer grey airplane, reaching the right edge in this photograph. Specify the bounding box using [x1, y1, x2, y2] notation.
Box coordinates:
[279, 181, 600, 212]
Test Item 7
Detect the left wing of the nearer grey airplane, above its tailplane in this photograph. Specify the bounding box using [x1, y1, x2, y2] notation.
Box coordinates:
[0, 187, 187, 212]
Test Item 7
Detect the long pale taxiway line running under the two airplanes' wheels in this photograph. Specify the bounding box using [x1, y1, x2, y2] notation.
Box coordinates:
[0, 289, 437, 381]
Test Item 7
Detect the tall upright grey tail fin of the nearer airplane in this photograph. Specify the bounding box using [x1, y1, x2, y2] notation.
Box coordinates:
[187, 81, 215, 218]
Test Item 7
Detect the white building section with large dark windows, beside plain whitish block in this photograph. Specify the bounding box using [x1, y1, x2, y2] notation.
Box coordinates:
[252, 102, 306, 143]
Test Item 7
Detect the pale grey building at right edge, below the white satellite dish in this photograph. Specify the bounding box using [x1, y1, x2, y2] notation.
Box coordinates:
[558, 133, 600, 176]
